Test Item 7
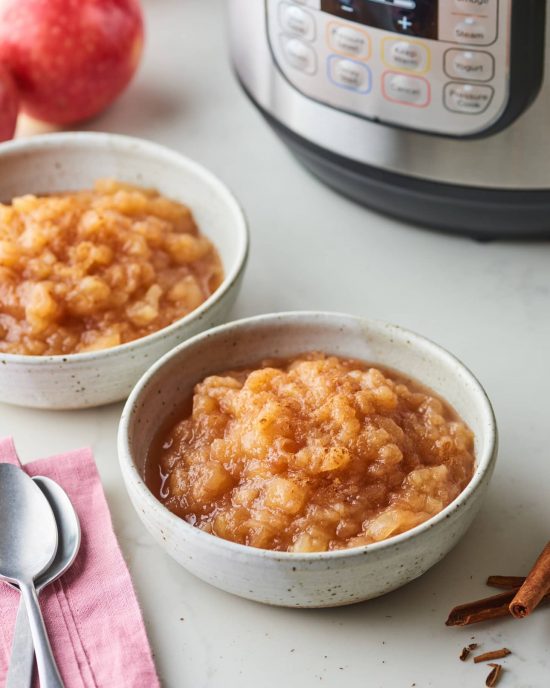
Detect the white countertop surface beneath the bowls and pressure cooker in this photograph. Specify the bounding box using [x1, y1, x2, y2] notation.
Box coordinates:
[0, 0, 550, 688]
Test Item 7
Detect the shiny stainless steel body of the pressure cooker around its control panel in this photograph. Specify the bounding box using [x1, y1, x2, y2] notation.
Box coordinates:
[228, 0, 550, 190]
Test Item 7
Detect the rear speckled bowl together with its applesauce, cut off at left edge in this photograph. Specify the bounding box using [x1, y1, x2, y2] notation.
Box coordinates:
[0, 132, 248, 409]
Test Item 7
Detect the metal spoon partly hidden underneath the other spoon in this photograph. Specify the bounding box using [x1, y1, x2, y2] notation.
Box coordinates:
[5, 476, 80, 688]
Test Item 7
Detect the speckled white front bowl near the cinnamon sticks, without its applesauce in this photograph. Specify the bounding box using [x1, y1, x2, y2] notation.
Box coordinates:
[118, 313, 497, 607]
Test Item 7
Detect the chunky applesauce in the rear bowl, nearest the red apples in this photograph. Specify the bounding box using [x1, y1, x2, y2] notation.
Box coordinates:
[0, 179, 223, 355]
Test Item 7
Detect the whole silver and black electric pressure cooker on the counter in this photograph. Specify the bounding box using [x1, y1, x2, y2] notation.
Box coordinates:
[228, 0, 550, 238]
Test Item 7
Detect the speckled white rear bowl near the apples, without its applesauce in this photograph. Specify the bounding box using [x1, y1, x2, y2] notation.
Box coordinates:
[0, 132, 248, 409]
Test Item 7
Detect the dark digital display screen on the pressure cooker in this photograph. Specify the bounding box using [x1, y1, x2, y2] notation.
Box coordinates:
[321, 0, 439, 39]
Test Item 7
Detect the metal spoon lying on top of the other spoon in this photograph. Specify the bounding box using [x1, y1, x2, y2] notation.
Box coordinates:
[0, 463, 63, 688]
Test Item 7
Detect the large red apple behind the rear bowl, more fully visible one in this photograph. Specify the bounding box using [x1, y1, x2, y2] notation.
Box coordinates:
[0, 0, 143, 125]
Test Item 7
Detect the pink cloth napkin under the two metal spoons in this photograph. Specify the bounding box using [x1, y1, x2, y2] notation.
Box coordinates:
[0, 439, 159, 688]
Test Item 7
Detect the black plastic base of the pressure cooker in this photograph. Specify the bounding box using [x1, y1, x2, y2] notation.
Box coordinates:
[259, 103, 550, 240]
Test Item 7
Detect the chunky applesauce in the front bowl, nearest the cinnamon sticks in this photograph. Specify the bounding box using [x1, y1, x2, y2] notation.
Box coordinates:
[149, 353, 474, 552]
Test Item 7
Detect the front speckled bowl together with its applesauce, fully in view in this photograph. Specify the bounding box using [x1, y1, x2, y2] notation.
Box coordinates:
[119, 313, 496, 606]
